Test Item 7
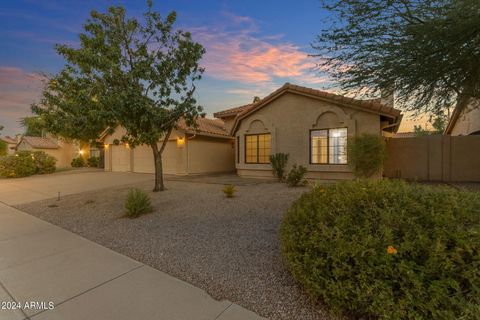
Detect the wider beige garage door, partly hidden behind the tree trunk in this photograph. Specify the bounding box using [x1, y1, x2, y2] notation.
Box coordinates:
[133, 141, 177, 174]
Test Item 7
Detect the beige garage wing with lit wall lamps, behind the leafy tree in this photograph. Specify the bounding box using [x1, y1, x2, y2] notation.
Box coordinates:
[100, 118, 235, 175]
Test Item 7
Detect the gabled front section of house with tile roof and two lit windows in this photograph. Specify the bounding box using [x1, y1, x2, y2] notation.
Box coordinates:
[214, 83, 402, 180]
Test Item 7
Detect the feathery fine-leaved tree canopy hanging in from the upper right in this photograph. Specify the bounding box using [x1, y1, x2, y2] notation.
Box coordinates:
[313, 0, 480, 113]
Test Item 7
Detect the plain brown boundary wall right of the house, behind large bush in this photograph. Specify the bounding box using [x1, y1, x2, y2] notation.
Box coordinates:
[384, 135, 480, 182]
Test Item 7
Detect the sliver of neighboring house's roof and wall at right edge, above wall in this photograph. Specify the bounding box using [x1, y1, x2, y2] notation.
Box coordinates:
[444, 103, 480, 136]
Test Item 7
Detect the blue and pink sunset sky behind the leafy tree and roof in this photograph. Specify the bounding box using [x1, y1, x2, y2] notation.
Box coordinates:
[0, 0, 428, 135]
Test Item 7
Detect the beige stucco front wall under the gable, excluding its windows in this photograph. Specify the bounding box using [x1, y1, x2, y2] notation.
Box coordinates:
[235, 93, 381, 180]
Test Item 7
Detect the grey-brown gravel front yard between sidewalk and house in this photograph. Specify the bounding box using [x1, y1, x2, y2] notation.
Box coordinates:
[18, 181, 338, 320]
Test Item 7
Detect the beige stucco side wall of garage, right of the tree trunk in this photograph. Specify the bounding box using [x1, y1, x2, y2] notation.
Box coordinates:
[187, 136, 235, 174]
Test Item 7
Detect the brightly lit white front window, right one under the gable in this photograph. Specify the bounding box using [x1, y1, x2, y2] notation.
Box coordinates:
[310, 128, 347, 164]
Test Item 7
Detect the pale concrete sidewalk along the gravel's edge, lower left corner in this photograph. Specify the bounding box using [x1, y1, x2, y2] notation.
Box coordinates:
[0, 203, 262, 320]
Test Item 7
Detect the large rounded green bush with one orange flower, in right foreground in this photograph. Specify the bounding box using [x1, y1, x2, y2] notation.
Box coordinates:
[281, 180, 480, 320]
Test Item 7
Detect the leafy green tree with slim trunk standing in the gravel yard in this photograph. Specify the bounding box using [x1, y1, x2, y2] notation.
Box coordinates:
[33, 1, 205, 191]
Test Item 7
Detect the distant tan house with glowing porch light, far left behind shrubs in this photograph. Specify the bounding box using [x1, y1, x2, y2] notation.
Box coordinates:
[17, 136, 84, 168]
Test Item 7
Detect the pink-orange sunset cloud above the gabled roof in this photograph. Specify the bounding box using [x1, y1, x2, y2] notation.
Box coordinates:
[191, 13, 326, 84]
